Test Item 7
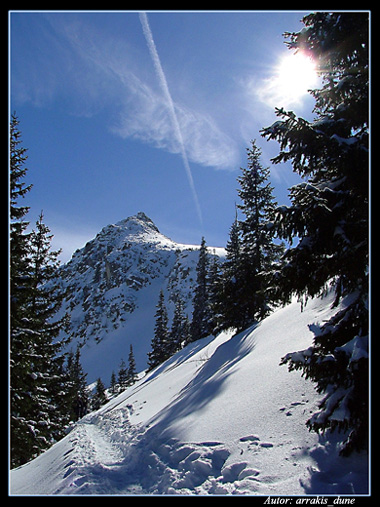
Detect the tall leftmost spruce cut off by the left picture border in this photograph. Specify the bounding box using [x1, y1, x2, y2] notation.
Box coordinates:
[9, 115, 33, 466]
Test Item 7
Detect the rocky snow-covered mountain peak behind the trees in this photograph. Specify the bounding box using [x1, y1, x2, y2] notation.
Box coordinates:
[53, 212, 225, 384]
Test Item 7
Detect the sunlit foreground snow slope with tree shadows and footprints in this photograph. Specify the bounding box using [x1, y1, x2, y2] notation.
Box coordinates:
[10, 297, 368, 495]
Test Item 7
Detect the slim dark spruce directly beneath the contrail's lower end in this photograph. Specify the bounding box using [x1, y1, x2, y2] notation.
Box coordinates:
[190, 237, 211, 342]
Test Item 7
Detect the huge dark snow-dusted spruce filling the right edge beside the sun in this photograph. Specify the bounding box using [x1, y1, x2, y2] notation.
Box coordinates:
[263, 12, 369, 454]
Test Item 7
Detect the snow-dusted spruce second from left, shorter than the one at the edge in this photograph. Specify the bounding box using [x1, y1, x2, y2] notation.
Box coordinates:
[19, 212, 68, 454]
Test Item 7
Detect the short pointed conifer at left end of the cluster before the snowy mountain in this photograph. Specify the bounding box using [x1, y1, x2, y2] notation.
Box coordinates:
[148, 289, 169, 370]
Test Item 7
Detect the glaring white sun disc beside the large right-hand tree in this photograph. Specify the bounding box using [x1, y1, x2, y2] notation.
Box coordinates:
[275, 53, 318, 102]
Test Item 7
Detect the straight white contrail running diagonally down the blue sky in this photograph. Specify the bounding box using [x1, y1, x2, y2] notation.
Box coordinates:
[139, 12, 203, 225]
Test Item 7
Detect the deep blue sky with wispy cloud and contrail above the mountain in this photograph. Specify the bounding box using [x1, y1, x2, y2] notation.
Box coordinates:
[9, 11, 314, 261]
